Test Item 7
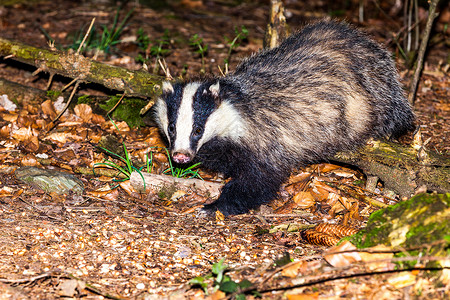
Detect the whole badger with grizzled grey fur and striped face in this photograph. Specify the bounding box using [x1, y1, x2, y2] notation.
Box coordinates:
[153, 21, 414, 215]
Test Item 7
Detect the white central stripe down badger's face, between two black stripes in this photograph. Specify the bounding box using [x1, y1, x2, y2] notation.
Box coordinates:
[173, 82, 200, 152]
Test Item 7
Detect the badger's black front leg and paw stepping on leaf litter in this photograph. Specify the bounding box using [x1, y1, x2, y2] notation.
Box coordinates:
[203, 172, 284, 216]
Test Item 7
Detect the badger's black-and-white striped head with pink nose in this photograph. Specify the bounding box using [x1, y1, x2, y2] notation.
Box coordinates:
[155, 80, 244, 163]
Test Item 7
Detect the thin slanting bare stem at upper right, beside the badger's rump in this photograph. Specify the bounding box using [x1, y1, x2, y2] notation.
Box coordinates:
[408, 0, 439, 105]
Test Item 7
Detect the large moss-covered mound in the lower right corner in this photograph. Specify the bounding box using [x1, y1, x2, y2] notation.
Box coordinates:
[349, 194, 450, 266]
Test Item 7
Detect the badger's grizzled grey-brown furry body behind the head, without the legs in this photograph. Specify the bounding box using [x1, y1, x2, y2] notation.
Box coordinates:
[225, 22, 414, 163]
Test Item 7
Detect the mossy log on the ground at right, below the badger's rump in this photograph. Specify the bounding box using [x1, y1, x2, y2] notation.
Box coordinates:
[334, 139, 450, 198]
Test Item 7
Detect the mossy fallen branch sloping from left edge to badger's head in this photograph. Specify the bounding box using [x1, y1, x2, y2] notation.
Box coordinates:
[0, 38, 164, 98]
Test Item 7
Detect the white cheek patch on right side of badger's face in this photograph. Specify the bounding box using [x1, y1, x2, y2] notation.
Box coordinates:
[196, 101, 245, 151]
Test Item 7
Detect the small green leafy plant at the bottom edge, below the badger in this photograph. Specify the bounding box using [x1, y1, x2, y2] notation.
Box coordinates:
[189, 259, 252, 300]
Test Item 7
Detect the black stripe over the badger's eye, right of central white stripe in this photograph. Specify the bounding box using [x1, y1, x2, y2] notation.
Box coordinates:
[191, 81, 219, 149]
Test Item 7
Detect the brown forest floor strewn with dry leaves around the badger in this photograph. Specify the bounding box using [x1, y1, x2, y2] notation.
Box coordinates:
[0, 0, 450, 299]
